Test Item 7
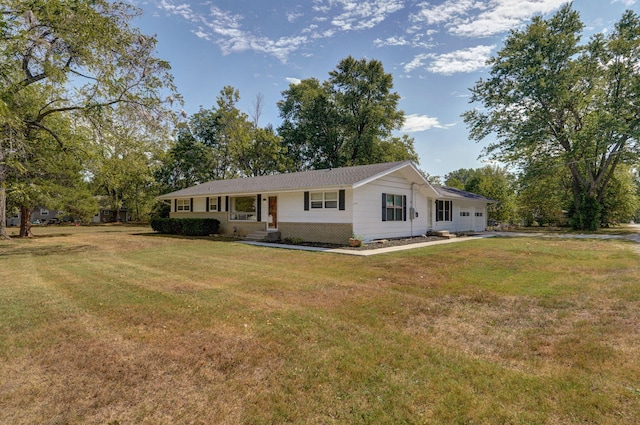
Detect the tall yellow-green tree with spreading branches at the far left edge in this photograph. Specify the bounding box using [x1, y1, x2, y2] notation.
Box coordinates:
[0, 0, 176, 238]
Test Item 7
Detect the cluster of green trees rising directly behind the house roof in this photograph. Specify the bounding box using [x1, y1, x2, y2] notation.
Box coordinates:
[156, 57, 418, 190]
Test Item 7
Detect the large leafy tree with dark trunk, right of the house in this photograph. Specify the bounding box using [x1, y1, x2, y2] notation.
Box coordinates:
[463, 4, 640, 229]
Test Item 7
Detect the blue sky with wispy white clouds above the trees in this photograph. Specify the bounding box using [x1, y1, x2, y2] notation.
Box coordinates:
[130, 0, 640, 177]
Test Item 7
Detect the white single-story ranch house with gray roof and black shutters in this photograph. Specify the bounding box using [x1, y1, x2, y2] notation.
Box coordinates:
[158, 161, 494, 244]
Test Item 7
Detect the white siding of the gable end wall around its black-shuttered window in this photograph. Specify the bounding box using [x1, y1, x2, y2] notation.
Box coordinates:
[353, 173, 429, 240]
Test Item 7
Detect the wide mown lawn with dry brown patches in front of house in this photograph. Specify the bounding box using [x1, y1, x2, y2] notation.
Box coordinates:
[0, 226, 640, 425]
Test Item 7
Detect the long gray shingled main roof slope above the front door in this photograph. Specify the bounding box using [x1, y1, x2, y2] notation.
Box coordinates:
[158, 161, 412, 199]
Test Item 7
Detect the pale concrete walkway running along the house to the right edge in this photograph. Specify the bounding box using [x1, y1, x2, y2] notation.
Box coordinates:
[241, 225, 640, 257]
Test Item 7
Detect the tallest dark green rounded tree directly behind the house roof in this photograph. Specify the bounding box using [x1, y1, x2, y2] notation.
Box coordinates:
[278, 56, 417, 171]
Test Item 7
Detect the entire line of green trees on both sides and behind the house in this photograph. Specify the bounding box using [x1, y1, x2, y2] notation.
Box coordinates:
[0, 0, 640, 239]
